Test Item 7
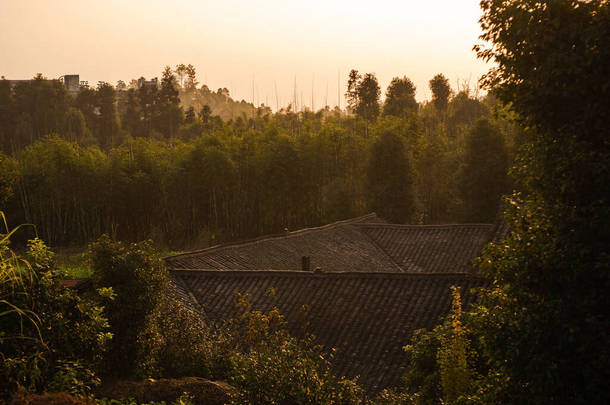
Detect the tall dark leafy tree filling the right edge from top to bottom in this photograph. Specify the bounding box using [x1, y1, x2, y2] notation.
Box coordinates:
[475, 0, 610, 404]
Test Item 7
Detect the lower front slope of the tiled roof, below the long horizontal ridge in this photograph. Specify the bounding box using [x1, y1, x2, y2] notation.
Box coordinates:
[171, 270, 485, 393]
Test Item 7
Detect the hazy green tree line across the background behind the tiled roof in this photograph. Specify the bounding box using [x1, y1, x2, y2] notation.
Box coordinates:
[0, 65, 519, 247]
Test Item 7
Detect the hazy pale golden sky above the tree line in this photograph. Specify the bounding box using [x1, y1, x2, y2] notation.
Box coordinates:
[0, 0, 487, 109]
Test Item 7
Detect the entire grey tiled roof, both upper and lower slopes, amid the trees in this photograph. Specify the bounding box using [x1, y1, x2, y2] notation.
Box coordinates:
[165, 214, 508, 393]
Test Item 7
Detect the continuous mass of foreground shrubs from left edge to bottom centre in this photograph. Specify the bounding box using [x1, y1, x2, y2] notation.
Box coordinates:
[0, 229, 376, 404]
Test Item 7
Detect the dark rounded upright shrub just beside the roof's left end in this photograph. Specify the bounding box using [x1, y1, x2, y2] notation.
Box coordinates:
[89, 235, 169, 378]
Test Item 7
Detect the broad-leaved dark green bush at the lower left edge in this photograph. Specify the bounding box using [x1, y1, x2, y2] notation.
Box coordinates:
[0, 229, 112, 402]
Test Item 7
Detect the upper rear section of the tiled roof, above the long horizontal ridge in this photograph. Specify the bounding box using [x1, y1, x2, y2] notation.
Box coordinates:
[166, 214, 493, 273]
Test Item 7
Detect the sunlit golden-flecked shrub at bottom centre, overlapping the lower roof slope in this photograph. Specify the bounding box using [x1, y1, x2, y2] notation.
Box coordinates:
[229, 296, 364, 404]
